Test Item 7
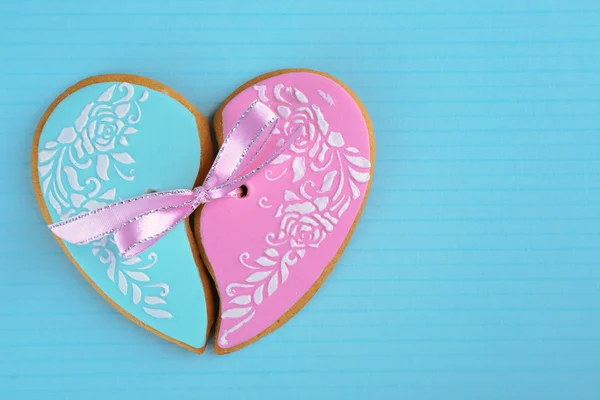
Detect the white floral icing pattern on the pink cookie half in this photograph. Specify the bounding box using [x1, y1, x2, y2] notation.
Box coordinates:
[218, 84, 371, 346]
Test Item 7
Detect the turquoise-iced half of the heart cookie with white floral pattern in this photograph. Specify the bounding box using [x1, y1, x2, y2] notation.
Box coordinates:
[31, 74, 214, 353]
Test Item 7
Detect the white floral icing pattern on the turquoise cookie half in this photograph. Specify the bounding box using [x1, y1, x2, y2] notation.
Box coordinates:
[38, 82, 173, 318]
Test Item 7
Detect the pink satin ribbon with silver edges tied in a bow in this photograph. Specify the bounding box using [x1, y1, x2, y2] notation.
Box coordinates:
[48, 101, 300, 257]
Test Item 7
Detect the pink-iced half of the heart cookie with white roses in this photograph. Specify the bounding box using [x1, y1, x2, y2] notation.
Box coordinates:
[196, 70, 375, 354]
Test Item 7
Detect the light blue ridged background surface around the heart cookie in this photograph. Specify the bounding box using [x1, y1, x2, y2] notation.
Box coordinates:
[0, 0, 600, 400]
